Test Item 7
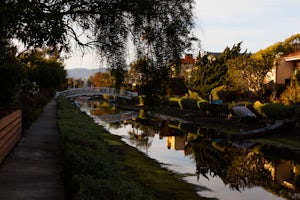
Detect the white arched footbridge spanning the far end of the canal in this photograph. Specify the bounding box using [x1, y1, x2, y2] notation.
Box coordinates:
[55, 87, 138, 99]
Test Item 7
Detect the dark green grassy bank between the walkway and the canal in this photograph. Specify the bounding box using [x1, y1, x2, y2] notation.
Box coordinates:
[58, 96, 201, 200]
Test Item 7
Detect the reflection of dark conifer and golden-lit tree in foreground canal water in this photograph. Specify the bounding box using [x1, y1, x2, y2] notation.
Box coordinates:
[185, 134, 293, 198]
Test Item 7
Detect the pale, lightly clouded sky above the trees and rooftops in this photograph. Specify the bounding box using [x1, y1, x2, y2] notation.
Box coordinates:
[65, 0, 300, 69]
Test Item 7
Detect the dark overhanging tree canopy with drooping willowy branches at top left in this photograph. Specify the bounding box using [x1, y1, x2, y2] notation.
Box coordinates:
[0, 0, 194, 72]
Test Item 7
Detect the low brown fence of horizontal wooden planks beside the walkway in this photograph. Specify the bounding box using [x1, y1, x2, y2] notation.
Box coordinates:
[0, 110, 22, 163]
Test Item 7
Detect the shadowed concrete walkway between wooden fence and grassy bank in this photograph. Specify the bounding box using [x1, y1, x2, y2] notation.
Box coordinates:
[0, 99, 65, 200]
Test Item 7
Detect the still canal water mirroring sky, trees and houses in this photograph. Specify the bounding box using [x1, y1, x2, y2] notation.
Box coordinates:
[80, 101, 300, 200]
